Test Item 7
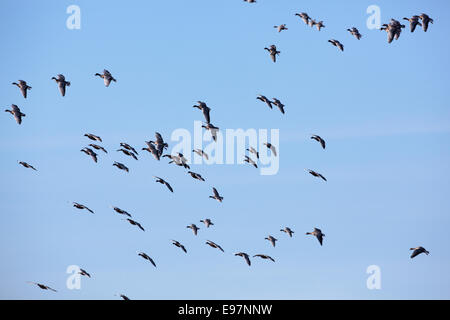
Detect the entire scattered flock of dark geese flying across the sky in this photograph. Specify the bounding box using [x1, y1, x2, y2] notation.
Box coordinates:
[5, 0, 433, 300]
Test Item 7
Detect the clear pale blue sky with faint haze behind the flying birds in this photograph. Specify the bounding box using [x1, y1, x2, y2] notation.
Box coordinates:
[0, 0, 450, 299]
